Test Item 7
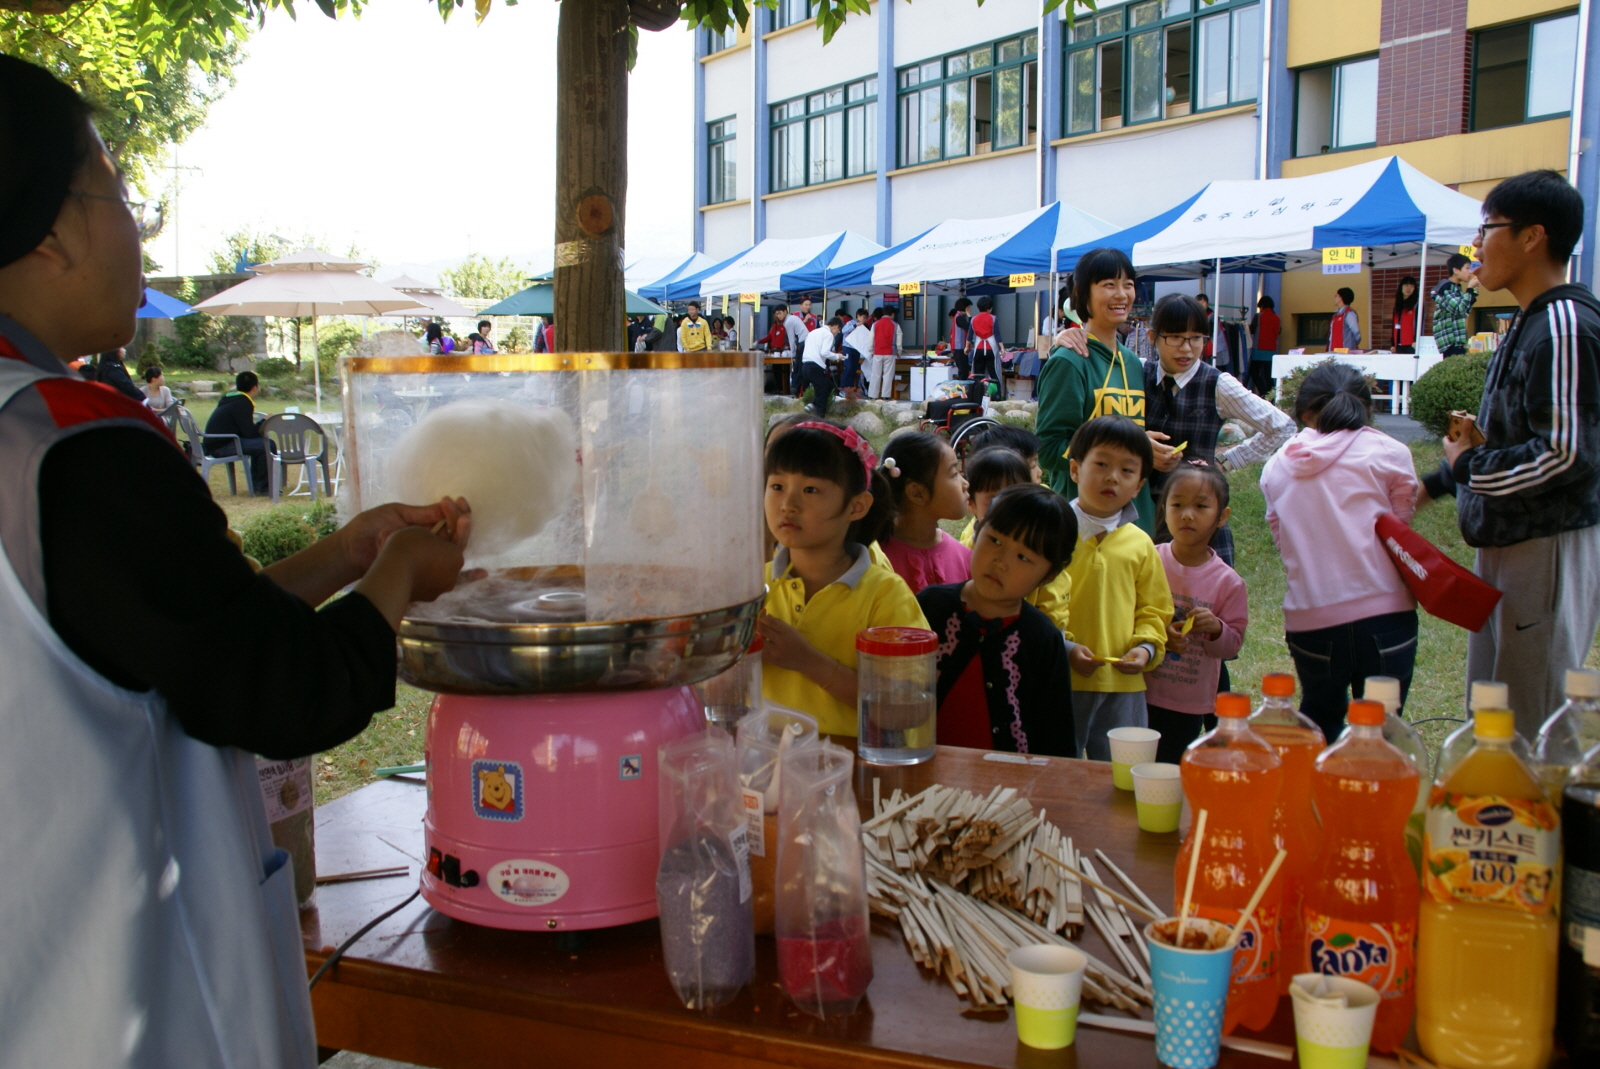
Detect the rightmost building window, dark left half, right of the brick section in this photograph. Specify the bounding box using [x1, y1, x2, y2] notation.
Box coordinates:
[1472, 14, 1578, 130]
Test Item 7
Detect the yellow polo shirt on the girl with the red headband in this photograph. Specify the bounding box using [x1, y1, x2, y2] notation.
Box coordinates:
[762, 546, 928, 736]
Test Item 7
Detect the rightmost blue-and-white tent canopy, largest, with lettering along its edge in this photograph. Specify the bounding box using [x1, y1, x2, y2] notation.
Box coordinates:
[1133, 157, 1483, 270]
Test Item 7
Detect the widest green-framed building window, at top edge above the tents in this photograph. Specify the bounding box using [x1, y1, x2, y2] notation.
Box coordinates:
[1062, 0, 1261, 136]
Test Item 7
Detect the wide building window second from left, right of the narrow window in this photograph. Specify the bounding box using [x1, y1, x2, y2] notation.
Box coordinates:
[771, 78, 878, 192]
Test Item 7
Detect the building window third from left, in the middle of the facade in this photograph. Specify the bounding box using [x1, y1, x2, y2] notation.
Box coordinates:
[898, 34, 1038, 166]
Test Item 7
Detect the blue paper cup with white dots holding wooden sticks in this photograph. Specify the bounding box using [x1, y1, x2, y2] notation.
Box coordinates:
[1144, 917, 1234, 1069]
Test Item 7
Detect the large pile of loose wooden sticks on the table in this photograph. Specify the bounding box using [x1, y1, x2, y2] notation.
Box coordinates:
[861, 779, 1165, 1011]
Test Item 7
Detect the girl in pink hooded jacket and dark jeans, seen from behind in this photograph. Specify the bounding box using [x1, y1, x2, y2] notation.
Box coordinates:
[1261, 363, 1418, 739]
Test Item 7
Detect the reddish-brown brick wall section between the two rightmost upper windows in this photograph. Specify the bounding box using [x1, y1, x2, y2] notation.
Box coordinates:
[1378, 0, 1472, 146]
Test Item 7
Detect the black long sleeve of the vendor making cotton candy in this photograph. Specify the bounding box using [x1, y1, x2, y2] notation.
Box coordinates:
[38, 427, 395, 759]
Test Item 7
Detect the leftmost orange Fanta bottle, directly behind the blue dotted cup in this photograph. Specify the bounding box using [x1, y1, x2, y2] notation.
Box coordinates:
[1173, 695, 1283, 1032]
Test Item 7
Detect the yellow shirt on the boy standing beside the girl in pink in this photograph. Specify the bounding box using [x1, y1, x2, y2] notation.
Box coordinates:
[1062, 504, 1173, 693]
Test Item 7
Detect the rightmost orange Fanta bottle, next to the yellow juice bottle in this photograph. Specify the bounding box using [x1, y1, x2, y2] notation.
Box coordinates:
[1305, 701, 1419, 1053]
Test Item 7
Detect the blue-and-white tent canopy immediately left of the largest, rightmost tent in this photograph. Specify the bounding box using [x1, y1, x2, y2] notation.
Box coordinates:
[872, 200, 1117, 286]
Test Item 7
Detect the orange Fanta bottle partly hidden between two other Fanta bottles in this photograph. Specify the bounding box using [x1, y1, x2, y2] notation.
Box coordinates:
[1250, 672, 1328, 995]
